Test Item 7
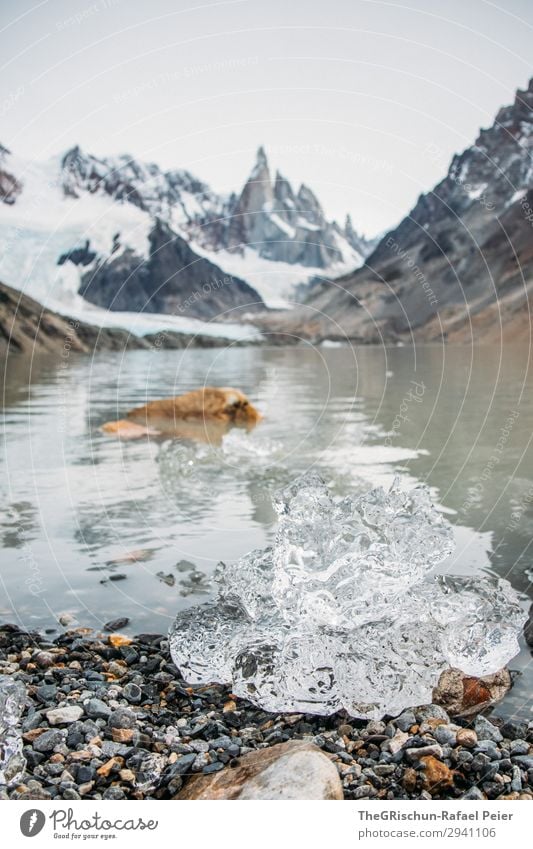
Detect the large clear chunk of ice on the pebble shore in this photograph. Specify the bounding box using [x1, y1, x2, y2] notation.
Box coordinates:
[169, 474, 525, 719]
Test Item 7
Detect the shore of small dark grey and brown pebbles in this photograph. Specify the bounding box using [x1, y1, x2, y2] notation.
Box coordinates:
[0, 625, 533, 800]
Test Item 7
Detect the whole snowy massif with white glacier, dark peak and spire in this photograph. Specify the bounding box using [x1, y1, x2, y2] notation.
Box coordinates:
[0, 147, 366, 332]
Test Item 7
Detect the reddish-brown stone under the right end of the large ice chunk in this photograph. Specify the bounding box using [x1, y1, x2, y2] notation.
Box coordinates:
[433, 669, 511, 716]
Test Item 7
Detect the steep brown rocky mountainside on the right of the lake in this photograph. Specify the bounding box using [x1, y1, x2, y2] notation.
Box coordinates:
[299, 80, 533, 342]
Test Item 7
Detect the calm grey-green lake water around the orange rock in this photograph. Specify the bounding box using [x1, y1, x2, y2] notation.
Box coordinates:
[0, 346, 533, 716]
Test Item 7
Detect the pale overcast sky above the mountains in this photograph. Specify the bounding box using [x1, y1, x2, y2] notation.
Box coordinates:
[0, 0, 533, 235]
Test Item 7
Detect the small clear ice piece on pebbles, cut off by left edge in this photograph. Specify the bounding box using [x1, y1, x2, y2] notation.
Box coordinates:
[0, 675, 26, 785]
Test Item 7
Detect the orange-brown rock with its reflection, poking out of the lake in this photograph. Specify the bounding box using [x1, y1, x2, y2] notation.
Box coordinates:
[102, 386, 261, 442]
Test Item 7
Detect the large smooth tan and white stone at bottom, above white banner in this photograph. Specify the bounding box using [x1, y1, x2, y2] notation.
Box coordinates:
[174, 741, 343, 800]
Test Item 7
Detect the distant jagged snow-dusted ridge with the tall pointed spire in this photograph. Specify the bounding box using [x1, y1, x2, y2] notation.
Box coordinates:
[61, 142, 366, 270]
